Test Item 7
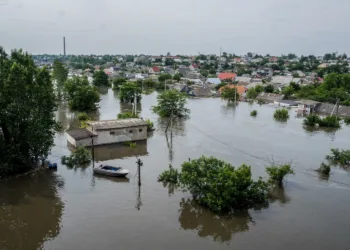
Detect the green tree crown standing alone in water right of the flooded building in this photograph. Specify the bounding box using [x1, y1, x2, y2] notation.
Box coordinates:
[152, 89, 190, 117]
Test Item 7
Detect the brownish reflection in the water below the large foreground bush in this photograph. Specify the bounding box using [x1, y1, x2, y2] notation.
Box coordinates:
[179, 199, 254, 242]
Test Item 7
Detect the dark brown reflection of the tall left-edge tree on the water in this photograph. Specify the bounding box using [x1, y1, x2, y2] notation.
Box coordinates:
[0, 172, 64, 249]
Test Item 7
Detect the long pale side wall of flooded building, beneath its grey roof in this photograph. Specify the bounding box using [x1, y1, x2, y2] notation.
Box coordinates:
[95, 126, 147, 145]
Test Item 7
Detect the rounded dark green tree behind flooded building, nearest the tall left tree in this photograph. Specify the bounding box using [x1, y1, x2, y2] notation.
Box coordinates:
[64, 77, 100, 111]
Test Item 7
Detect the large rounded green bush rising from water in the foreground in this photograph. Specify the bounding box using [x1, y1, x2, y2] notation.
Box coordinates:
[180, 156, 268, 212]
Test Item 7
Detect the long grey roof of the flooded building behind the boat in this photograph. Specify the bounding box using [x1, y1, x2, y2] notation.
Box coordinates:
[87, 118, 147, 130]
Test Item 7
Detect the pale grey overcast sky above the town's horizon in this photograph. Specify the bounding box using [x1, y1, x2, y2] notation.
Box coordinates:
[0, 0, 350, 55]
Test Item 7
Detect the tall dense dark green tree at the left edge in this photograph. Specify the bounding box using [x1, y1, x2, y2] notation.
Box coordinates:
[0, 47, 59, 178]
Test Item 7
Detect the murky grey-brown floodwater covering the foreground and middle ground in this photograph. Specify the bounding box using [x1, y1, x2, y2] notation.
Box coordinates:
[0, 90, 350, 250]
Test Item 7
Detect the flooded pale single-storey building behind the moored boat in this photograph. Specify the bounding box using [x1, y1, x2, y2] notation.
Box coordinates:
[67, 118, 147, 147]
